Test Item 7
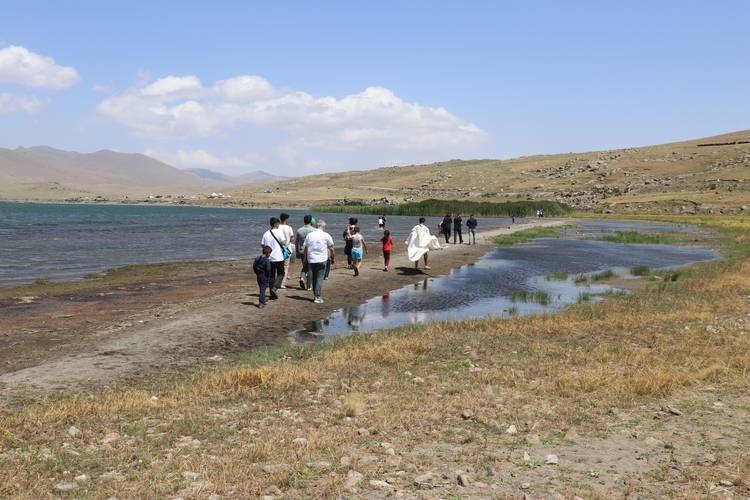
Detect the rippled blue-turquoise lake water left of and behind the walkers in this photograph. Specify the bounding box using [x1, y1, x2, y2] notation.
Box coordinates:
[0, 202, 503, 286]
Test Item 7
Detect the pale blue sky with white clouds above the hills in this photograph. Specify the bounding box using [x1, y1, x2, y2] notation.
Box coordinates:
[0, 0, 750, 176]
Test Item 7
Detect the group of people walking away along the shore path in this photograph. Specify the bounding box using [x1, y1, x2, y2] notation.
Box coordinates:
[253, 213, 477, 307]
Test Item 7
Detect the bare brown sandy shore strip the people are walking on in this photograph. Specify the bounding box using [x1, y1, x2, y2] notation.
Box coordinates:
[0, 220, 566, 396]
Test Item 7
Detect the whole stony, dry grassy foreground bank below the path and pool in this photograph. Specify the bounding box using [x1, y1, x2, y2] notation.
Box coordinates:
[0, 217, 750, 498]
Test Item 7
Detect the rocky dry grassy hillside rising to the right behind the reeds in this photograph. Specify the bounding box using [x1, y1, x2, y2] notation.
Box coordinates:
[229, 130, 750, 213]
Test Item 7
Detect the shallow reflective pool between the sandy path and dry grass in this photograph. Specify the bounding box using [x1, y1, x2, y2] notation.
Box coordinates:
[294, 222, 717, 342]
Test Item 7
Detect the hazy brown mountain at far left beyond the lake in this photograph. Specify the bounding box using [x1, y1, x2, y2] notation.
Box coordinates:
[0, 146, 206, 192]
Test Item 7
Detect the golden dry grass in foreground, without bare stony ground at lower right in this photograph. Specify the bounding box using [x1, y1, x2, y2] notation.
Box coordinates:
[0, 217, 750, 498]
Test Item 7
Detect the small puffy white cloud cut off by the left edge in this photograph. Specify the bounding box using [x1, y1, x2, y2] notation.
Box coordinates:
[0, 45, 80, 89]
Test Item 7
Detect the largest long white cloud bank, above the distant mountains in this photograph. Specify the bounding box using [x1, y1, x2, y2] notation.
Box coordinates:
[98, 75, 485, 150]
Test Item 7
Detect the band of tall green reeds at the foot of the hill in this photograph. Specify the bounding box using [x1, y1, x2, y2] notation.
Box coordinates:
[311, 199, 570, 217]
